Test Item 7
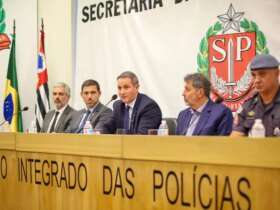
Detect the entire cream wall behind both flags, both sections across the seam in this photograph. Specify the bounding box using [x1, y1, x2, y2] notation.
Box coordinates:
[0, 0, 73, 130]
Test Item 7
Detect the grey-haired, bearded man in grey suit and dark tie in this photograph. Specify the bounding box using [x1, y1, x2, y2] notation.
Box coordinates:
[41, 82, 75, 133]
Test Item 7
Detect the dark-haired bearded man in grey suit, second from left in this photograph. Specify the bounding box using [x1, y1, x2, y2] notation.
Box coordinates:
[69, 79, 112, 133]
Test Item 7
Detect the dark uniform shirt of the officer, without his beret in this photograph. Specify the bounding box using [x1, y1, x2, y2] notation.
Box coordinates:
[233, 89, 280, 136]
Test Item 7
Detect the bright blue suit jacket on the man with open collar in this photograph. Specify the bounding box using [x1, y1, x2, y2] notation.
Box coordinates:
[176, 100, 233, 136]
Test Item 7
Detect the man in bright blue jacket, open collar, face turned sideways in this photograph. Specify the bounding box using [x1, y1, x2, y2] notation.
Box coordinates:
[176, 73, 233, 136]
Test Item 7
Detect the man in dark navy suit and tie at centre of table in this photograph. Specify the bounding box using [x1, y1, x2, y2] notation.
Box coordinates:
[105, 71, 162, 134]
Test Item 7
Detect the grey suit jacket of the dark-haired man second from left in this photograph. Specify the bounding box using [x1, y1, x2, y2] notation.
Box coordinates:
[67, 103, 112, 133]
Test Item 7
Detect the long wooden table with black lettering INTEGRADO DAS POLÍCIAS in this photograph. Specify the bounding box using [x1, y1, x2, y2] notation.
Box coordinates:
[0, 133, 280, 210]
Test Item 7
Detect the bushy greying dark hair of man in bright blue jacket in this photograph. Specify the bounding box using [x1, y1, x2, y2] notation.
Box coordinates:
[184, 73, 211, 98]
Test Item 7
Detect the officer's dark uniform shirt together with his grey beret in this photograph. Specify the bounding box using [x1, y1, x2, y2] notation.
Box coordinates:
[233, 54, 280, 136]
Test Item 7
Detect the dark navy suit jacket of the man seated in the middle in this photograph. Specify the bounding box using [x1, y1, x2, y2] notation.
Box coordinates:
[105, 93, 162, 134]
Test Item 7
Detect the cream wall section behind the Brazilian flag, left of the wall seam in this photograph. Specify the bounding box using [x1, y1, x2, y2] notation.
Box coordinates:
[0, 0, 37, 131]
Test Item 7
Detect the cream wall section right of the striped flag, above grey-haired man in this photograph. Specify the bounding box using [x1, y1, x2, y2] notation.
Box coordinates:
[38, 0, 73, 104]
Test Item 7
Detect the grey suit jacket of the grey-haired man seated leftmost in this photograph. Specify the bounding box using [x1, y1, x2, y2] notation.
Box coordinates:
[40, 105, 76, 133]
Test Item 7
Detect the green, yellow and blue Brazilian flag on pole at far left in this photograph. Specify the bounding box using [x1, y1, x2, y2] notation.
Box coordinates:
[3, 33, 23, 132]
